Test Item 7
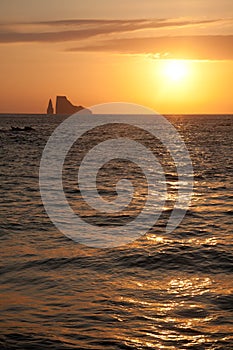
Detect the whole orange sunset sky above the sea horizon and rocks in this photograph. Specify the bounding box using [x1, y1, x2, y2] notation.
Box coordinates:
[0, 0, 233, 114]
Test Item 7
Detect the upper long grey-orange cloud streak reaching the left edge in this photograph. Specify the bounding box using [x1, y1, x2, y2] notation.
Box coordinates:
[0, 19, 222, 43]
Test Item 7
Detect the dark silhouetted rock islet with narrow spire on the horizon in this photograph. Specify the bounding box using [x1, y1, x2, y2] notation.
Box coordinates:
[47, 96, 91, 115]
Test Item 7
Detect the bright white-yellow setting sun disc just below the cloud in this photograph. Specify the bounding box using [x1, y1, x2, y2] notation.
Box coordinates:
[163, 60, 188, 82]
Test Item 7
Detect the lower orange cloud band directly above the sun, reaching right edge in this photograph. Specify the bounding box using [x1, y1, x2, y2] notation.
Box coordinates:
[69, 35, 233, 60]
